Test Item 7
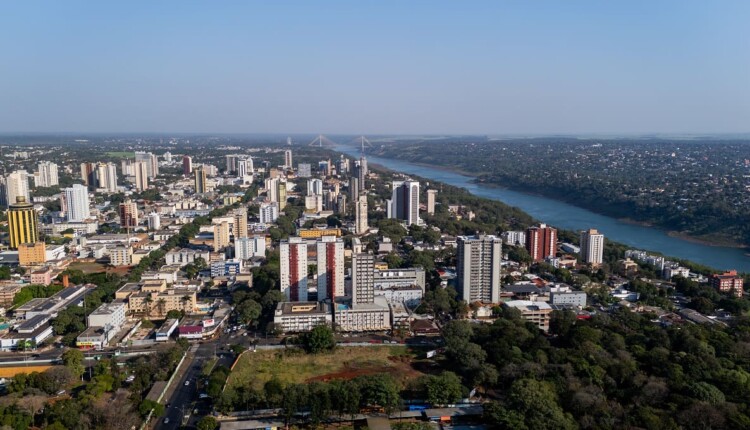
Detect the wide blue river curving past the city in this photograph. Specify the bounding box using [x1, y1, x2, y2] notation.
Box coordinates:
[335, 145, 750, 272]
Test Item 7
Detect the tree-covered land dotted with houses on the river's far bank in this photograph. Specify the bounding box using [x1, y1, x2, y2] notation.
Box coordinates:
[375, 138, 750, 245]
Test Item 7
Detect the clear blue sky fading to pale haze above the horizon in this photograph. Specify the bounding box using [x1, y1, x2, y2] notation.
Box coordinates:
[0, 0, 750, 134]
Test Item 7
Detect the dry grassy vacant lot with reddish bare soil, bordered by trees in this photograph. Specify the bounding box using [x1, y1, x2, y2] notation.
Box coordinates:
[227, 345, 422, 390]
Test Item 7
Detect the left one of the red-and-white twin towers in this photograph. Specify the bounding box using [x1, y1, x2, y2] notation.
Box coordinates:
[279, 237, 307, 302]
